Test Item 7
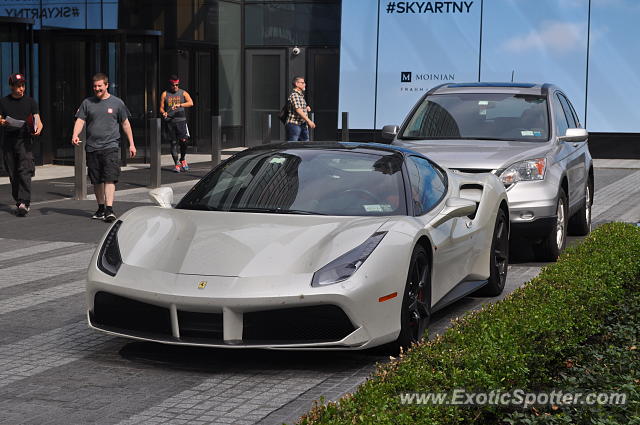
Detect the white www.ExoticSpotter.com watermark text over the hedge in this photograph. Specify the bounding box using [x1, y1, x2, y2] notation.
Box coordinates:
[398, 388, 627, 409]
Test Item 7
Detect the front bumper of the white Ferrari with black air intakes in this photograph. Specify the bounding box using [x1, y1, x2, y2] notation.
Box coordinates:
[87, 265, 401, 349]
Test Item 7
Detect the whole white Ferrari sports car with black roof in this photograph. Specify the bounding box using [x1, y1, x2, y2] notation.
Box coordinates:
[87, 143, 509, 349]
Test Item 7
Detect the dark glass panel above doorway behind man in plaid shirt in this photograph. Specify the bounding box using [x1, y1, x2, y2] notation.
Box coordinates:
[245, 2, 340, 46]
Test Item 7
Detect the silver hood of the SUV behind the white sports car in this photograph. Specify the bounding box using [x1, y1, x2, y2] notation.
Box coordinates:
[394, 140, 550, 170]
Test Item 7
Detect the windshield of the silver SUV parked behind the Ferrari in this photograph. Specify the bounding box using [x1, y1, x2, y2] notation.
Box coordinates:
[400, 93, 549, 141]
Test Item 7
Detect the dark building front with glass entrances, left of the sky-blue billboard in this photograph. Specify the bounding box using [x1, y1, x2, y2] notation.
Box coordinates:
[0, 0, 341, 169]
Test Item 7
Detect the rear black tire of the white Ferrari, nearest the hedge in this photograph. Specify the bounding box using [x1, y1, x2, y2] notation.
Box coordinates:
[477, 208, 509, 297]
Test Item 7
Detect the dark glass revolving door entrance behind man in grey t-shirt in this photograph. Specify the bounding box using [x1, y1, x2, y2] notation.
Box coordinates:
[38, 29, 159, 165]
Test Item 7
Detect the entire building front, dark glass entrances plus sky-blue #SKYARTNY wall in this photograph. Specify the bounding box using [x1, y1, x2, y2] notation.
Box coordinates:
[0, 0, 640, 171]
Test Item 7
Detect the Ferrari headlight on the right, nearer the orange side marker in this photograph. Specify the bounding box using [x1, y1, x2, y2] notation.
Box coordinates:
[311, 232, 387, 286]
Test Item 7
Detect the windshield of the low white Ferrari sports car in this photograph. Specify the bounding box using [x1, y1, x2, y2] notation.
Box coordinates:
[177, 148, 407, 215]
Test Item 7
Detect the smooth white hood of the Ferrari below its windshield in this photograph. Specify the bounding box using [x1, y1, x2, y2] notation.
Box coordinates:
[118, 207, 388, 277]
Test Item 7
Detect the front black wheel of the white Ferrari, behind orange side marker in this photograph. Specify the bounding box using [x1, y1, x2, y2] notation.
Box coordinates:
[396, 245, 431, 348]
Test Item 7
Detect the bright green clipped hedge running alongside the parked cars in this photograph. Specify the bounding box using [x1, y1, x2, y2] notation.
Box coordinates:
[299, 223, 640, 424]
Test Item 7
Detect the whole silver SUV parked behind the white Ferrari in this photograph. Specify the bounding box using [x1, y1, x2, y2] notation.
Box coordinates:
[382, 83, 593, 261]
